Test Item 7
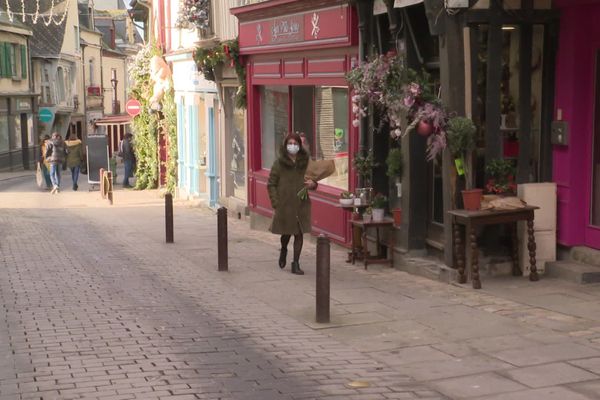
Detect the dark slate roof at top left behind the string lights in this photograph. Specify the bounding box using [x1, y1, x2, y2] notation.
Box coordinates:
[6, 0, 67, 58]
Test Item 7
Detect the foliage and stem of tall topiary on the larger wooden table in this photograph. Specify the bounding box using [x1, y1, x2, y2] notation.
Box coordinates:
[447, 117, 477, 190]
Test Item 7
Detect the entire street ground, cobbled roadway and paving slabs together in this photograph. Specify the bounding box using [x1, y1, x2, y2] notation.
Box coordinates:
[0, 175, 600, 400]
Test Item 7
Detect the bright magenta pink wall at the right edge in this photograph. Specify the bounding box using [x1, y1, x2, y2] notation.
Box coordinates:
[553, 1, 600, 247]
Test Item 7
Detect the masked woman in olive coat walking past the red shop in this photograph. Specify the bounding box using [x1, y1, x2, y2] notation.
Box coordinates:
[267, 133, 317, 275]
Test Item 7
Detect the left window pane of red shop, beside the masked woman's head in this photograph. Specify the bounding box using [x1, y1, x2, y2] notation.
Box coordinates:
[260, 86, 289, 169]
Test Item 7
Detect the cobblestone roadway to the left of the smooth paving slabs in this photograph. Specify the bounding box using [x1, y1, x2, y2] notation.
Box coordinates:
[0, 184, 442, 400]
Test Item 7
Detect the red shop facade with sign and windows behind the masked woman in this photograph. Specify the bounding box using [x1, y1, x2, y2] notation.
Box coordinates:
[232, 0, 358, 243]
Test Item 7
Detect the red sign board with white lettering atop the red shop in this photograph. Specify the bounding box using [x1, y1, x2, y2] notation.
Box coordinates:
[240, 5, 351, 54]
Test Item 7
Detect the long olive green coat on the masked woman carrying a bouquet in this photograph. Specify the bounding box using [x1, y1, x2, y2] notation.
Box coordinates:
[267, 149, 311, 235]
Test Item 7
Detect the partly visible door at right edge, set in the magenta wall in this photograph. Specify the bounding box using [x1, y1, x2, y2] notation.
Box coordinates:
[585, 49, 600, 249]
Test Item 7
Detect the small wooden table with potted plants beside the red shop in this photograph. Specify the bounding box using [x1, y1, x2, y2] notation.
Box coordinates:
[350, 217, 394, 269]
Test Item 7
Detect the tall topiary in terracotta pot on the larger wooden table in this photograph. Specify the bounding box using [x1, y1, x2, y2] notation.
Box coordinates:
[447, 117, 483, 210]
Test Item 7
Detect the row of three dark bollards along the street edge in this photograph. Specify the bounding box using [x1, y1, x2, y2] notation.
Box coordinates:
[165, 200, 331, 323]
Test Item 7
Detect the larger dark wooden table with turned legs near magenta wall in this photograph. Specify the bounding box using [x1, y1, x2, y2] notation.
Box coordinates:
[448, 206, 539, 289]
